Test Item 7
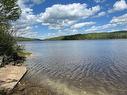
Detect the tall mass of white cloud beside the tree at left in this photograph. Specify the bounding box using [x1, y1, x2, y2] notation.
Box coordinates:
[12, 0, 38, 37]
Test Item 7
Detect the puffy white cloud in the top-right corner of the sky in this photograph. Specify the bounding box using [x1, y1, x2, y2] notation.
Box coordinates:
[108, 0, 127, 13]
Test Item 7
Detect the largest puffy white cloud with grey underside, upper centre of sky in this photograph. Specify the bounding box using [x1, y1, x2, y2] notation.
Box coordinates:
[40, 3, 100, 29]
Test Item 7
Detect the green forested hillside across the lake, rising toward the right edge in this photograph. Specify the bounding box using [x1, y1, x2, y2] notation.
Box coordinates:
[46, 31, 127, 40]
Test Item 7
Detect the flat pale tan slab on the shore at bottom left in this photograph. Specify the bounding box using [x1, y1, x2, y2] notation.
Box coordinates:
[0, 65, 27, 95]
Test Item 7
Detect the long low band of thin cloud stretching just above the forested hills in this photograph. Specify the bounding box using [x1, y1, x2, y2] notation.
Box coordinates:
[42, 20, 127, 39]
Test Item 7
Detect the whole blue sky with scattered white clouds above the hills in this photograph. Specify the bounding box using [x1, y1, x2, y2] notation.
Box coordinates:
[13, 0, 127, 39]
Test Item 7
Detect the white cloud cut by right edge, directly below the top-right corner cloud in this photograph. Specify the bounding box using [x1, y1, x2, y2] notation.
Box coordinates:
[110, 13, 127, 24]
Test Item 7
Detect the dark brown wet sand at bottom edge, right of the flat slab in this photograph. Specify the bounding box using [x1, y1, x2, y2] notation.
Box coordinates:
[10, 79, 56, 95]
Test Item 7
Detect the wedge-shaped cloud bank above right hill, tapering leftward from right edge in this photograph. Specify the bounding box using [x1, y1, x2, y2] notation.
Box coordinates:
[86, 14, 127, 32]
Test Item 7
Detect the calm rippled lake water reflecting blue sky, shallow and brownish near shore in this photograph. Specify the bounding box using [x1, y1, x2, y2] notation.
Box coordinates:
[20, 40, 127, 95]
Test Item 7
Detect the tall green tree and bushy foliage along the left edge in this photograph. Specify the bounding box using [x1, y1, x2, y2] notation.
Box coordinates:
[0, 0, 21, 67]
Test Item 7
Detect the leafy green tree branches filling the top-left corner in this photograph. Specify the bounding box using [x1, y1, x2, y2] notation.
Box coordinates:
[0, 0, 21, 23]
